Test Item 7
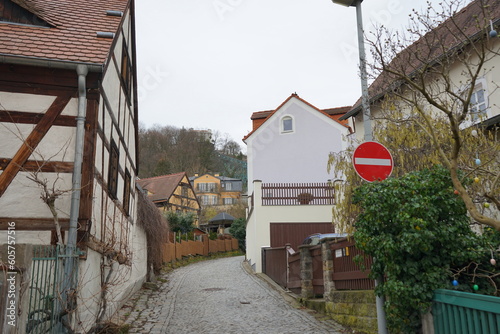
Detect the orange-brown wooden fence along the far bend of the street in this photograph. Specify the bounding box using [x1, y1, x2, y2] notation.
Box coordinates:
[161, 236, 238, 262]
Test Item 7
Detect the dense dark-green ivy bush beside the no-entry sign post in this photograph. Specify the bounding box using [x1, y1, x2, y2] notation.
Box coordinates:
[353, 166, 483, 333]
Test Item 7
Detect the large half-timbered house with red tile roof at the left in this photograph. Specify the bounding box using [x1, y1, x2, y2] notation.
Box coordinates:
[0, 0, 146, 333]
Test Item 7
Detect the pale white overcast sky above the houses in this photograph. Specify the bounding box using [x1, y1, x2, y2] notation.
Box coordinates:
[136, 0, 444, 147]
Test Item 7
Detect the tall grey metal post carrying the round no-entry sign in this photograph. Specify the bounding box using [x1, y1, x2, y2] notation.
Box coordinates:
[332, 0, 387, 334]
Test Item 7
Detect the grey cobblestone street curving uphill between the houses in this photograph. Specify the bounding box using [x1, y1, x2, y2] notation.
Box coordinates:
[120, 256, 346, 334]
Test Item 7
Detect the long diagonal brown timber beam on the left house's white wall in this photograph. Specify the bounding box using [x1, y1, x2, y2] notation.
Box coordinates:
[0, 95, 71, 197]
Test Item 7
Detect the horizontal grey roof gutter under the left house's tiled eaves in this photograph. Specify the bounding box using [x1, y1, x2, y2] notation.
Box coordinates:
[0, 54, 104, 73]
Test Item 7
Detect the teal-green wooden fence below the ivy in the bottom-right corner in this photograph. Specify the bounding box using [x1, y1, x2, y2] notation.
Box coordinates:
[432, 289, 500, 334]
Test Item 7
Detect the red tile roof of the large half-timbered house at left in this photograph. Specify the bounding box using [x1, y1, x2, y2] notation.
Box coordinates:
[0, 0, 128, 64]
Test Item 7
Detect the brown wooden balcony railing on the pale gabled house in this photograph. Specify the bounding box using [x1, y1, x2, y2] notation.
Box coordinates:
[262, 183, 335, 205]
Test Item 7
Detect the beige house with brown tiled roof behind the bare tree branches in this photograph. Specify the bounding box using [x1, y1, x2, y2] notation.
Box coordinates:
[340, 0, 500, 141]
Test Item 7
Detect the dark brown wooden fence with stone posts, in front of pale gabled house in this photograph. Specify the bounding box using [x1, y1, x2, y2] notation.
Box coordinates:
[262, 238, 374, 296]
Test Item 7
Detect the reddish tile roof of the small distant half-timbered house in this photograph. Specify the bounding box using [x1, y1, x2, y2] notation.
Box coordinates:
[137, 172, 189, 202]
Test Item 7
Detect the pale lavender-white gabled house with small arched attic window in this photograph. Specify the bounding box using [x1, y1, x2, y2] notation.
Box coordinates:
[243, 94, 351, 272]
